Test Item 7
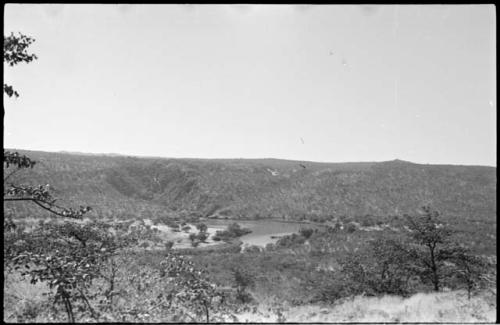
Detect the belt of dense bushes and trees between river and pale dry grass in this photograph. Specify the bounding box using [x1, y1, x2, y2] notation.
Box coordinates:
[4, 204, 496, 322]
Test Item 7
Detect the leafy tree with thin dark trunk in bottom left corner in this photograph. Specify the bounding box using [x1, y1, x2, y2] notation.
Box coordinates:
[4, 221, 120, 322]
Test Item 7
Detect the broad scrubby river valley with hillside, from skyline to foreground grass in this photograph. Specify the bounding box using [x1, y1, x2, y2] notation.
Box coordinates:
[4, 151, 496, 322]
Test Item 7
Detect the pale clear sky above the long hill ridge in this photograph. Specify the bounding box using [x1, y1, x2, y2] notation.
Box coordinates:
[4, 4, 497, 166]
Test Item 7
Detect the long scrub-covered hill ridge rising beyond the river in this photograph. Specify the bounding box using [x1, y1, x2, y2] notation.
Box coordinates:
[6, 150, 496, 227]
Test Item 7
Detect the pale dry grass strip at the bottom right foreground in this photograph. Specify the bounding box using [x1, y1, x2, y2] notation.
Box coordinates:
[229, 291, 496, 323]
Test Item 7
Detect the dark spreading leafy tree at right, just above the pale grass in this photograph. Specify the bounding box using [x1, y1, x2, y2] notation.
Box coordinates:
[334, 207, 486, 296]
